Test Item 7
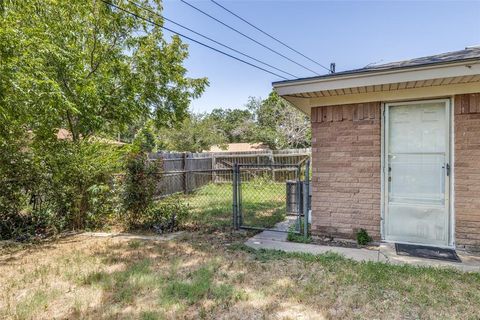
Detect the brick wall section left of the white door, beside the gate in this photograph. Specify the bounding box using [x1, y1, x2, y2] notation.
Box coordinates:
[312, 102, 381, 239]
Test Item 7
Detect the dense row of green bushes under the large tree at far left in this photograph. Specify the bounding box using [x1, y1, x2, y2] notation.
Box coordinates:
[0, 136, 122, 240]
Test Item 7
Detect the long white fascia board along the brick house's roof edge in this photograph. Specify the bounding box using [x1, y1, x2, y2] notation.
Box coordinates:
[273, 61, 480, 96]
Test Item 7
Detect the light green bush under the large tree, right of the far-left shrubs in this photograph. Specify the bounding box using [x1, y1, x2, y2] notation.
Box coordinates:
[39, 141, 122, 230]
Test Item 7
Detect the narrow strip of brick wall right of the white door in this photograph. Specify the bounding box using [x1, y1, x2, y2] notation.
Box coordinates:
[454, 93, 480, 250]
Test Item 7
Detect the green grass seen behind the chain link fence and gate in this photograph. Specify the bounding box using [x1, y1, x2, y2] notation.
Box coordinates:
[185, 179, 286, 230]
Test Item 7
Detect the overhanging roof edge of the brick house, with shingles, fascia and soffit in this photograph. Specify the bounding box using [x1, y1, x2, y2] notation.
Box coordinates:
[273, 46, 480, 114]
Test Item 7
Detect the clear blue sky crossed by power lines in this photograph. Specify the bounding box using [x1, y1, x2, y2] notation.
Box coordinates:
[163, 0, 480, 112]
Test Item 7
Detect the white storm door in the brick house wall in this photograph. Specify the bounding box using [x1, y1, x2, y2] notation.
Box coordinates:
[384, 100, 450, 246]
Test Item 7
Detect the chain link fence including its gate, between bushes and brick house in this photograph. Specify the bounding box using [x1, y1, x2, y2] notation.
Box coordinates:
[147, 163, 312, 233]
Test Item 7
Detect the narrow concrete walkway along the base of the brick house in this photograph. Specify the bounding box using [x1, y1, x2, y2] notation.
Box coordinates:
[245, 222, 480, 272]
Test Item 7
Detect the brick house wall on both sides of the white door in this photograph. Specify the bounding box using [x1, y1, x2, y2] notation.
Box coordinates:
[311, 93, 480, 250]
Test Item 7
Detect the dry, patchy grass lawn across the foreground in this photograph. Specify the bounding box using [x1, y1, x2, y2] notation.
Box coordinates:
[0, 233, 480, 319]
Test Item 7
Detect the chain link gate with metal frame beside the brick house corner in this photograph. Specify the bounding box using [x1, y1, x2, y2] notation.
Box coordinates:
[232, 160, 310, 236]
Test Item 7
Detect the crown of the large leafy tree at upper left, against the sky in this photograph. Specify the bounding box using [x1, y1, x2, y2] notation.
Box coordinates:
[0, 0, 207, 141]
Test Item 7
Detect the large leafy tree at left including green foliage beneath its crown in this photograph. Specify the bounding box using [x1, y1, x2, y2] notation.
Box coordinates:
[0, 0, 208, 237]
